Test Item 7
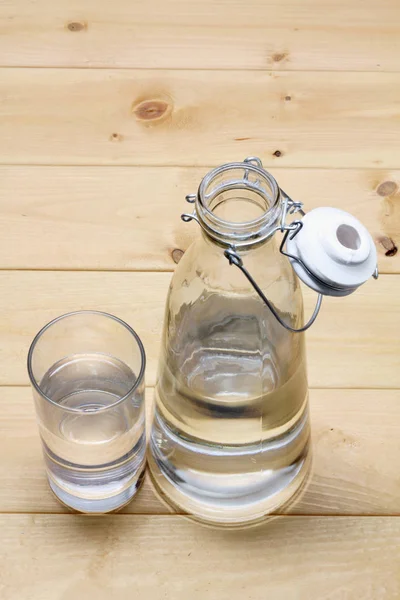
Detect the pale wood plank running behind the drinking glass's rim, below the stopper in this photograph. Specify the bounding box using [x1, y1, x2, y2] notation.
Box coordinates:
[0, 271, 400, 388]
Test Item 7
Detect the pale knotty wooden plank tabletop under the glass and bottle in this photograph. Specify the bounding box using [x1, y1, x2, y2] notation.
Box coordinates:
[0, 0, 400, 600]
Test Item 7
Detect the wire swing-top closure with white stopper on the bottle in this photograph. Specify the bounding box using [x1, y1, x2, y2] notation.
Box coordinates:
[181, 156, 378, 333]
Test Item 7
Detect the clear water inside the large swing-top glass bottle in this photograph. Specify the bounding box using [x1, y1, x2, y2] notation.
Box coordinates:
[149, 297, 310, 526]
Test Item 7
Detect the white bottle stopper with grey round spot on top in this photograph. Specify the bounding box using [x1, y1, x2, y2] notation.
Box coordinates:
[286, 207, 377, 296]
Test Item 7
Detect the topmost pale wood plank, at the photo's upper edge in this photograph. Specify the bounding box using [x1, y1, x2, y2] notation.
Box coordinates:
[0, 0, 400, 71]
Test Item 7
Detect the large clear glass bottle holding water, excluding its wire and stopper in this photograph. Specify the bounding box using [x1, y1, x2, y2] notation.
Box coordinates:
[149, 167, 311, 527]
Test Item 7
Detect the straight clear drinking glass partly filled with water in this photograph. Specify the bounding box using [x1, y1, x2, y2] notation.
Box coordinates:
[28, 311, 146, 513]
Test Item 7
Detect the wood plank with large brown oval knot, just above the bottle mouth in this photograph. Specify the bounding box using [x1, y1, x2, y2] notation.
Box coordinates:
[0, 68, 400, 168]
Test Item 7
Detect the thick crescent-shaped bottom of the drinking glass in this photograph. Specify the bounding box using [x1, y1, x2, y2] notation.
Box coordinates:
[48, 466, 145, 514]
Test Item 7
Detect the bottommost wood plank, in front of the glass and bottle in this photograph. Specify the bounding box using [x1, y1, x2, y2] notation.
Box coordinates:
[0, 515, 400, 600]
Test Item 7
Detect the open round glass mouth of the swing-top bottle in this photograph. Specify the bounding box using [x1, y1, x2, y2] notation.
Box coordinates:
[196, 159, 281, 247]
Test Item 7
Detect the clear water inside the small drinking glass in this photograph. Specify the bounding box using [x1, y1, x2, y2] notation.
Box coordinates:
[39, 354, 146, 512]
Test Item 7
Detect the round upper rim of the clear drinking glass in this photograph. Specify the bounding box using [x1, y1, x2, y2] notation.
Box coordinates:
[27, 310, 146, 416]
